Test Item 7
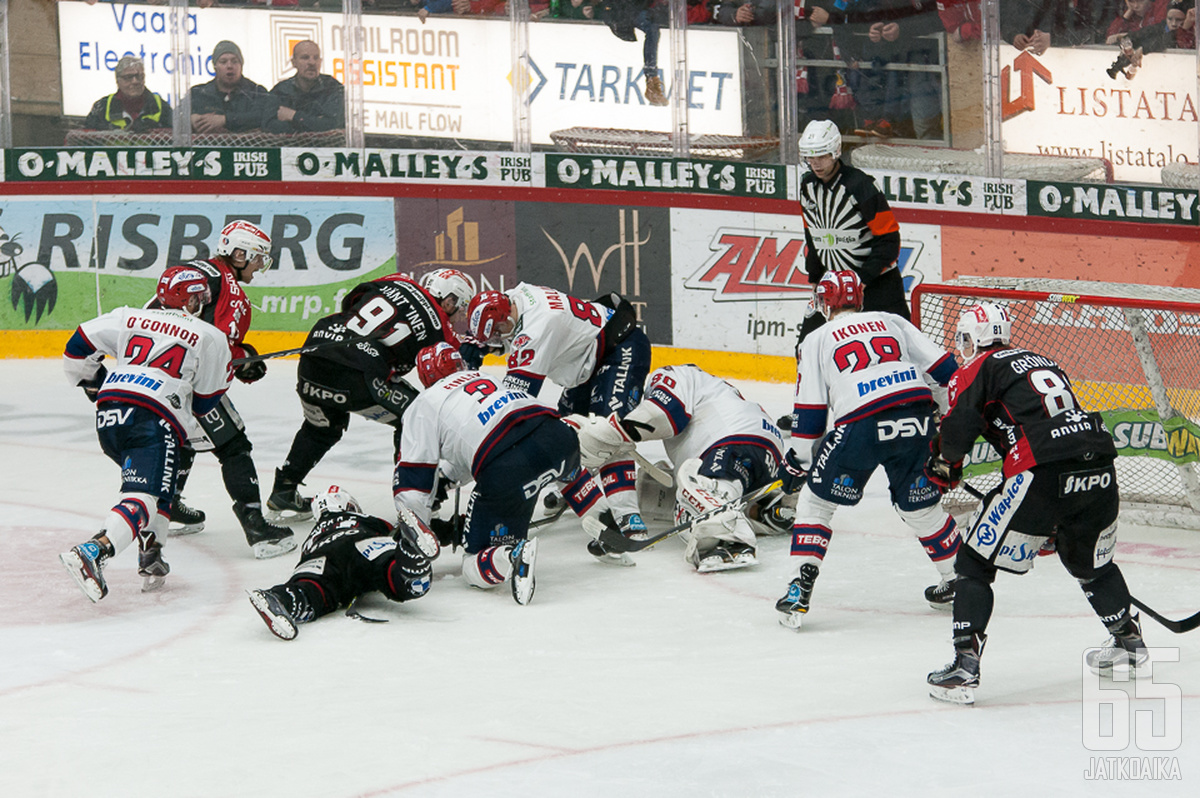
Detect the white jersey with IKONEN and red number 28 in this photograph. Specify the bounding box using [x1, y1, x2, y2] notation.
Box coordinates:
[792, 311, 958, 439]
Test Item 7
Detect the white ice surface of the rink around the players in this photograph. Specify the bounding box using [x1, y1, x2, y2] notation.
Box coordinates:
[0, 360, 1200, 798]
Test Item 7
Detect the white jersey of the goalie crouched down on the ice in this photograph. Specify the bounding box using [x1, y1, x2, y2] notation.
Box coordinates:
[625, 365, 784, 467]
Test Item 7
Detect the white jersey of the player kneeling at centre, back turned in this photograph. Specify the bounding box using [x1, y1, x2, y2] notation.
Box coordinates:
[392, 371, 557, 522]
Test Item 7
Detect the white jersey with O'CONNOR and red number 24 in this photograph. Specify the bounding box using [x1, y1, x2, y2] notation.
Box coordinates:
[62, 307, 230, 438]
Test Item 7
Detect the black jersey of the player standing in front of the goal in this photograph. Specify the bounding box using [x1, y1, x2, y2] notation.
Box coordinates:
[942, 348, 1117, 478]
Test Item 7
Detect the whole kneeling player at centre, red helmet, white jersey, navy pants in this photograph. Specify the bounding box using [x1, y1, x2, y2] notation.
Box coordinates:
[392, 343, 580, 604]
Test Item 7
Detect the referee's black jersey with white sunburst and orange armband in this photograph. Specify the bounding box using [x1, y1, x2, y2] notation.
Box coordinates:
[799, 163, 900, 288]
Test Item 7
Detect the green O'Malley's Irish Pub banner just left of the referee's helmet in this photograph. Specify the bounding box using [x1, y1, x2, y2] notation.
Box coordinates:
[546, 154, 787, 199]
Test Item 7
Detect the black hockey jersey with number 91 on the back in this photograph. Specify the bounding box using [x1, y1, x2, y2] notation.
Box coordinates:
[304, 275, 458, 373]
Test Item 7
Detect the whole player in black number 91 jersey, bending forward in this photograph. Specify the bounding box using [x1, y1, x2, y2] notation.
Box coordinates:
[266, 269, 465, 521]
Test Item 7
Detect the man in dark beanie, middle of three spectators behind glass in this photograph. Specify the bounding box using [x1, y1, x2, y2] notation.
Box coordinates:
[188, 41, 289, 133]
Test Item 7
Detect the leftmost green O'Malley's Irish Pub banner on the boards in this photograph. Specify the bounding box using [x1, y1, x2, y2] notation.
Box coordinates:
[5, 148, 280, 180]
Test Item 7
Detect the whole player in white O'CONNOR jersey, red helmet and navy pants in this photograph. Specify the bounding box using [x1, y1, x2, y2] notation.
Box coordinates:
[60, 266, 229, 601]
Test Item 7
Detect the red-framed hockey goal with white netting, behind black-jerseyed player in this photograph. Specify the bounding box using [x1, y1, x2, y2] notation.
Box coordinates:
[912, 278, 1200, 529]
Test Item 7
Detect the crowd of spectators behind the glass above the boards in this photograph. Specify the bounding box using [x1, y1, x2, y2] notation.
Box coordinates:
[77, 0, 1195, 139]
